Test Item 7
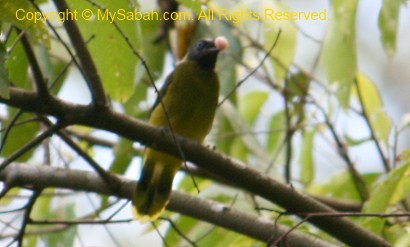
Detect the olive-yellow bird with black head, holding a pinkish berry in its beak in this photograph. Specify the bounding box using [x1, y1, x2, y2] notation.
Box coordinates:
[133, 36, 229, 223]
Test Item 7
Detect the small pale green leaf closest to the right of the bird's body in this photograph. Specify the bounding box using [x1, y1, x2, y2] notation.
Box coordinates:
[239, 91, 269, 125]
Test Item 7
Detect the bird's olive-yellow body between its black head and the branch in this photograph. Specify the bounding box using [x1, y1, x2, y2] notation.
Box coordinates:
[149, 61, 219, 141]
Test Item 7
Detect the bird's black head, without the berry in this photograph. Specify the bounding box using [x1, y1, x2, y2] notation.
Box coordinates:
[188, 40, 221, 69]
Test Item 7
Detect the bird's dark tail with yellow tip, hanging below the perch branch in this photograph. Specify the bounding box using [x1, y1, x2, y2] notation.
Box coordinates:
[134, 154, 179, 223]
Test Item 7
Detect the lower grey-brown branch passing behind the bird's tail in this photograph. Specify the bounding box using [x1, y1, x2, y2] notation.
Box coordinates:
[0, 164, 333, 247]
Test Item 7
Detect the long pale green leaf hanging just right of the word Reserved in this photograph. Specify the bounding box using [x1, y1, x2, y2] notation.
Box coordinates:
[323, 0, 358, 108]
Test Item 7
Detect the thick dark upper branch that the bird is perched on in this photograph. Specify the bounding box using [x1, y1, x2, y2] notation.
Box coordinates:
[0, 88, 390, 246]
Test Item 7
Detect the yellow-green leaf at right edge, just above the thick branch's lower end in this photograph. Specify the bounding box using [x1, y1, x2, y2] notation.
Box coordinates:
[362, 163, 410, 234]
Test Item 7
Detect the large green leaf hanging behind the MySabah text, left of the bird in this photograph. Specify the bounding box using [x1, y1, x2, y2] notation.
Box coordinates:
[70, 0, 142, 102]
